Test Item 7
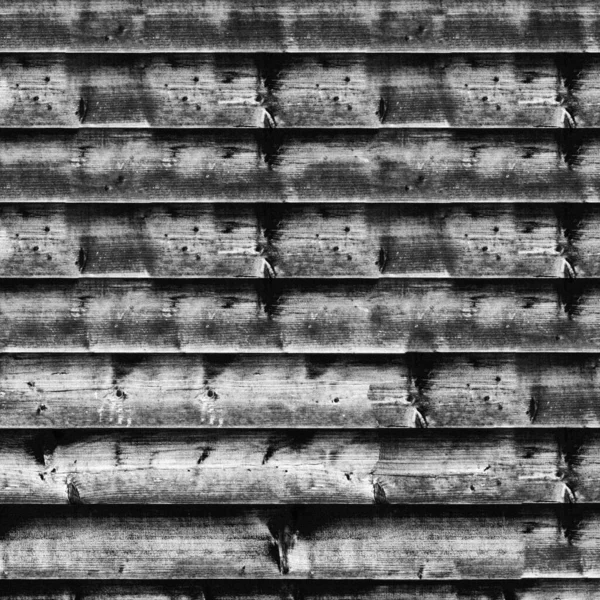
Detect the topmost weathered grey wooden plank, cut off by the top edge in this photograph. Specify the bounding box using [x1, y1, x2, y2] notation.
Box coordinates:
[5, 0, 600, 52]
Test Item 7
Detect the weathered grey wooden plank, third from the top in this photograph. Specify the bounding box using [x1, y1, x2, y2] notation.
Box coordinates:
[0, 129, 600, 203]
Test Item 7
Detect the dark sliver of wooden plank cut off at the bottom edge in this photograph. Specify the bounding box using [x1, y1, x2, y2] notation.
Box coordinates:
[0, 579, 598, 600]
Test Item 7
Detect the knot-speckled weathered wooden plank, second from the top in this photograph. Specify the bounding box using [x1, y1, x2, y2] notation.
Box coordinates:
[0, 54, 600, 129]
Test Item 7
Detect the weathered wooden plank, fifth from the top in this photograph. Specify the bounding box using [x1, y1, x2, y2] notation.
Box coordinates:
[0, 279, 600, 354]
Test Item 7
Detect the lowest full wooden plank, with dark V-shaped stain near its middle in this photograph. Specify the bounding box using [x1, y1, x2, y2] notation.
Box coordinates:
[0, 506, 600, 581]
